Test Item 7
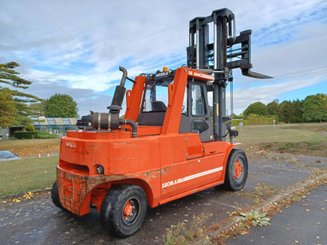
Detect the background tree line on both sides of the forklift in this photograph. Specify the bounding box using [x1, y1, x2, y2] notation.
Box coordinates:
[0, 62, 327, 127]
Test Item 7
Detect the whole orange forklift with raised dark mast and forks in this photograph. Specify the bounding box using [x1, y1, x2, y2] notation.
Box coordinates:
[51, 9, 269, 238]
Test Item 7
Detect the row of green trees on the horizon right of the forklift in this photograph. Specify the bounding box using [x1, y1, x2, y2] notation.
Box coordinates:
[243, 93, 327, 123]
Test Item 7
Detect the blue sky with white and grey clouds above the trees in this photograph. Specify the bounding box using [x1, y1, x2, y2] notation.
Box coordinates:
[0, 0, 327, 116]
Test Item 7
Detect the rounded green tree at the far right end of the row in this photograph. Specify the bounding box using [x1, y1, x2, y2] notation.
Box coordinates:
[303, 94, 327, 122]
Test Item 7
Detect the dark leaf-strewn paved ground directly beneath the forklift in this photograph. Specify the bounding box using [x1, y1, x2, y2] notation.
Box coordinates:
[0, 152, 327, 244]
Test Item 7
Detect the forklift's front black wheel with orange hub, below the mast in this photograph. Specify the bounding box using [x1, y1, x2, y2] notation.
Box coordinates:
[225, 149, 248, 191]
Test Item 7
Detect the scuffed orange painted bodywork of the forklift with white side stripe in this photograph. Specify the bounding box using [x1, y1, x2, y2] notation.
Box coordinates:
[57, 67, 234, 215]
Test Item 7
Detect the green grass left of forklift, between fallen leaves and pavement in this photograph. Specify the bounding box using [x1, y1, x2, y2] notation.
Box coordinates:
[0, 156, 58, 197]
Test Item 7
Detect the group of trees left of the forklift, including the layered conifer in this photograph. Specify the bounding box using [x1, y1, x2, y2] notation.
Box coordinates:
[0, 62, 77, 129]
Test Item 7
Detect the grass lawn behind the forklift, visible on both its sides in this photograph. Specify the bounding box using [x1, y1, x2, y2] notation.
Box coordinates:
[0, 123, 327, 197]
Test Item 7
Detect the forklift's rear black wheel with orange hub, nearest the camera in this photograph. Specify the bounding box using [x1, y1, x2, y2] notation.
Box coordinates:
[100, 185, 147, 238]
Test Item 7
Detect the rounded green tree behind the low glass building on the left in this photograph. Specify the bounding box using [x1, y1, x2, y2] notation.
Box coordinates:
[44, 94, 77, 117]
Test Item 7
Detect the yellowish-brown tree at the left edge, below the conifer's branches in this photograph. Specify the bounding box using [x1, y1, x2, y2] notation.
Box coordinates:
[0, 88, 17, 128]
